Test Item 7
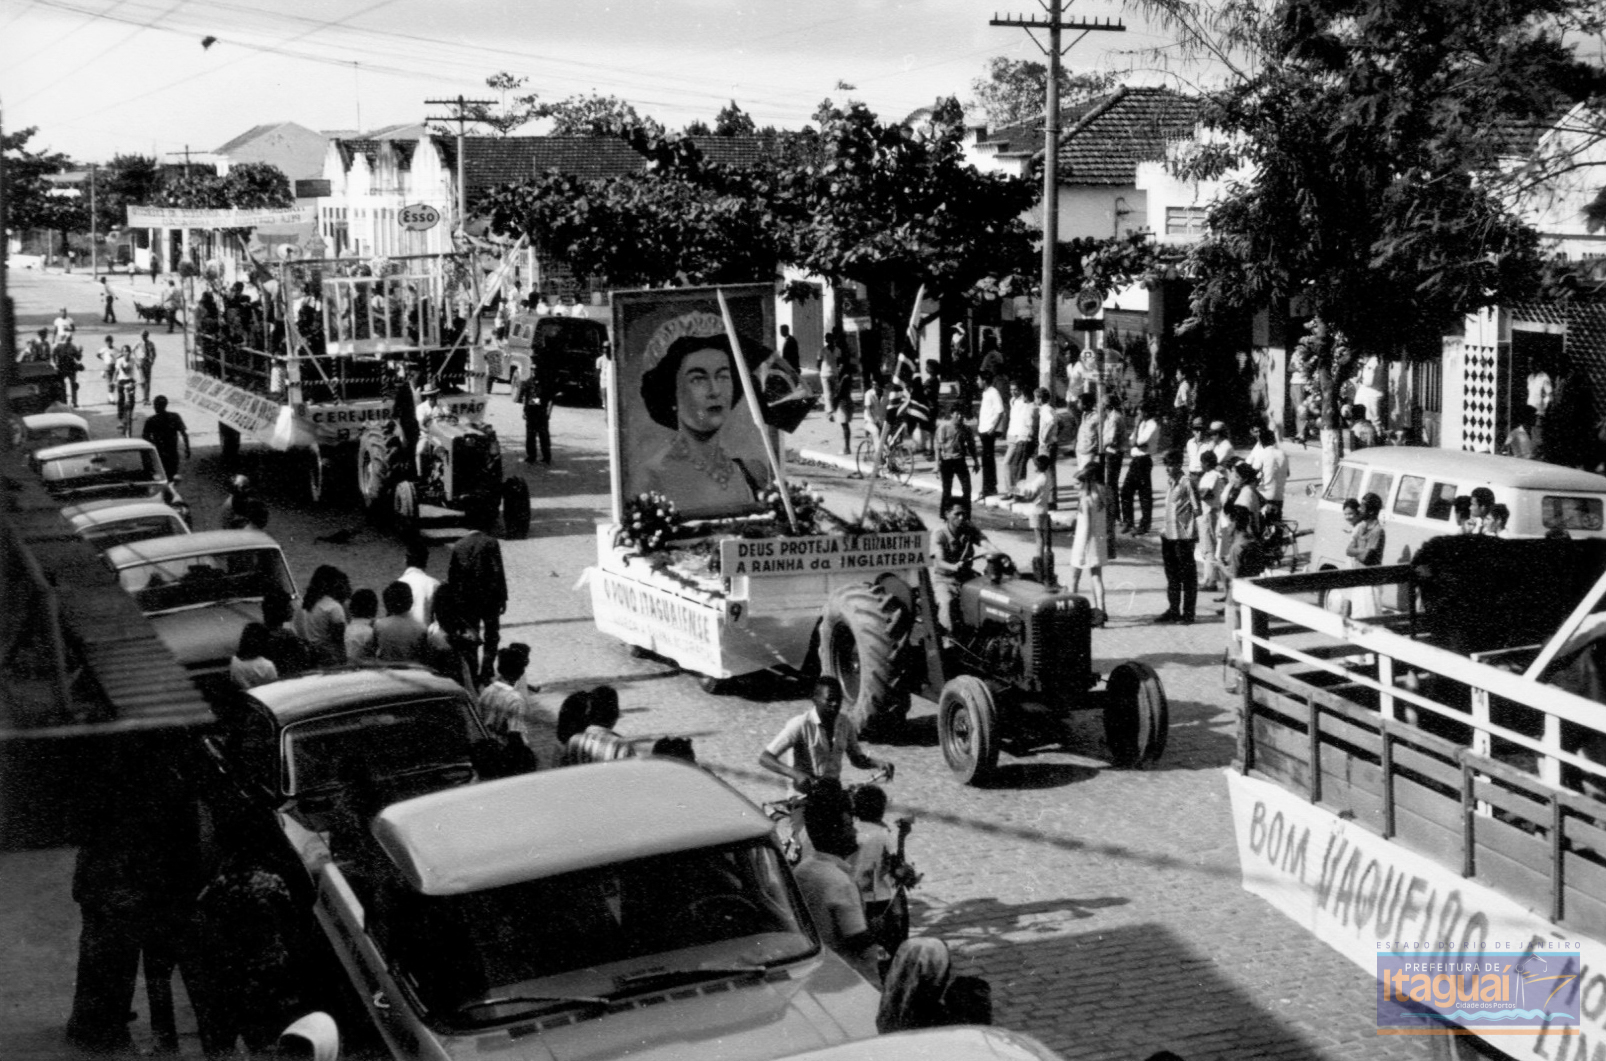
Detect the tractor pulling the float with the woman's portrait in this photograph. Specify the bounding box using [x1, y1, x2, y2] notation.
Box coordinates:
[817, 554, 1169, 785]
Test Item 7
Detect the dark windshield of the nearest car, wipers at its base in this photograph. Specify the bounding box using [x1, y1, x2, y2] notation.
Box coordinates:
[369, 836, 816, 1027]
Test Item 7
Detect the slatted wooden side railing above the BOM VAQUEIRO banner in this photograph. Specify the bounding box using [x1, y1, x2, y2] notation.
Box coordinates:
[1233, 567, 1606, 936]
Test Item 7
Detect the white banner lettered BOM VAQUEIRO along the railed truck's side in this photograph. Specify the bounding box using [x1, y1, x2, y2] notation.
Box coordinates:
[1227, 770, 1606, 1061]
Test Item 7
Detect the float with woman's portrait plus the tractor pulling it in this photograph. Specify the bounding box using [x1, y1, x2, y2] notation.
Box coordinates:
[588, 284, 1169, 783]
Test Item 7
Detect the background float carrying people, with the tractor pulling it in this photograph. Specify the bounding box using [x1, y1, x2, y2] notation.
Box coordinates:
[185, 254, 530, 535]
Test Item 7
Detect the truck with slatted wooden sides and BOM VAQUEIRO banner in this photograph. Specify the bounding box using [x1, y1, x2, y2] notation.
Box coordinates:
[1229, 535, 1606, 1061]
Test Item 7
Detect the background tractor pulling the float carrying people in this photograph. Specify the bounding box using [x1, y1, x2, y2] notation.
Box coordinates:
[357, 403, 530, 538]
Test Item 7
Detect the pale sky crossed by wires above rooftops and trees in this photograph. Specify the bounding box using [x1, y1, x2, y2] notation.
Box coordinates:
[0, 0, 1194, 162]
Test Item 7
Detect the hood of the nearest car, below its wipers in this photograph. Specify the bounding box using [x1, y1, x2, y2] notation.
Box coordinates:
[450, 953, 880, 1061]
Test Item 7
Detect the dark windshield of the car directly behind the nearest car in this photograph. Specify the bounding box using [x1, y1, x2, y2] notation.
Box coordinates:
[281, 698, 480, 799]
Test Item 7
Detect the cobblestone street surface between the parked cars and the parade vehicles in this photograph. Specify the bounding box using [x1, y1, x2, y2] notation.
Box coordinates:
[0, 266, 1490, 1061]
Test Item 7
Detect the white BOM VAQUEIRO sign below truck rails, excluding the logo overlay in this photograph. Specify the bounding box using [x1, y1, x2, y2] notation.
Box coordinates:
[1227, 770, 1606, 1061]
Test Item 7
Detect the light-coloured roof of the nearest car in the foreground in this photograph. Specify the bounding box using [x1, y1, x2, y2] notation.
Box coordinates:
[374, 758, 772, 896]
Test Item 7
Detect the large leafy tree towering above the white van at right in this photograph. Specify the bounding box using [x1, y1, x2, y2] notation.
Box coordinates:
[1177, 0, 1598, 464]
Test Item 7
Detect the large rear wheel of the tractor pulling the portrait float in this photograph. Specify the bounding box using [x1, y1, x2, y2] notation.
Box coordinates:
[821, 586, 912, 734]
